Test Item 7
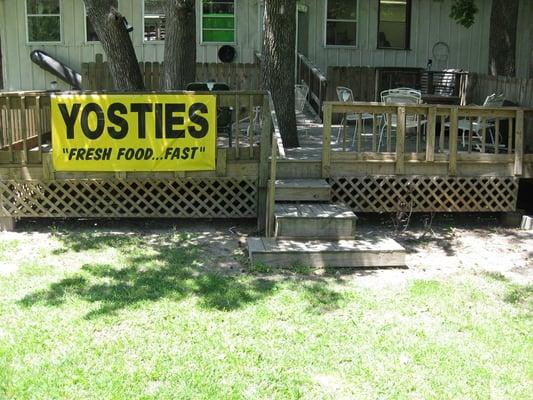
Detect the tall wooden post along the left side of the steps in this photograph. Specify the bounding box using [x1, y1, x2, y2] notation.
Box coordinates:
[257, 94, 272, 232]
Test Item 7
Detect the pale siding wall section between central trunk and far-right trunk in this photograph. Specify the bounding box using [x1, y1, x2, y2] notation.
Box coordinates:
[304, 0, 491, 72]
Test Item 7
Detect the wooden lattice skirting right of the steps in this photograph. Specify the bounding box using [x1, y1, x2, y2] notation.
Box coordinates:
[330, 176, 518, 212]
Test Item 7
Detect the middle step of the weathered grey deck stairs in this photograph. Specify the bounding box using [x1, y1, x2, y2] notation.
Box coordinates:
[274, 203, 357, 239]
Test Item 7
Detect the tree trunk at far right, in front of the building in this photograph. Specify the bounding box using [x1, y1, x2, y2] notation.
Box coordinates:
[489, 0, 519, 76]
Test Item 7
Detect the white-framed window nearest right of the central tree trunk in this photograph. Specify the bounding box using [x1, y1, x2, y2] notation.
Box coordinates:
[326, 0, 357, 46]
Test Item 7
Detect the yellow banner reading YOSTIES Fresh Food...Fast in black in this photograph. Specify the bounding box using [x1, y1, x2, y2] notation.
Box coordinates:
[52, 94, 217, 171]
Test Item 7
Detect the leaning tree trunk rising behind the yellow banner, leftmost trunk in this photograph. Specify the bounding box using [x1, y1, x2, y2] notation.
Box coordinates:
[83, 0, 144, 91]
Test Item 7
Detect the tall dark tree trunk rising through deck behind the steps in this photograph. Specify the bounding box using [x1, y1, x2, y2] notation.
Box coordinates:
[261, 0, 298, 147]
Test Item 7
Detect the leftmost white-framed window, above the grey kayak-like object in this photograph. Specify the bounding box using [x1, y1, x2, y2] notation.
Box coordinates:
[26, 0, 61, 42]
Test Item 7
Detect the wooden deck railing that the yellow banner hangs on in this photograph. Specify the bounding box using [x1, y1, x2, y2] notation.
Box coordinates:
[0, 91, 272, 168]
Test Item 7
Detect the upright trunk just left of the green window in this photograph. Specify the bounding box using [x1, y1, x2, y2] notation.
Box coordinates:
[161, 0, 196, 90]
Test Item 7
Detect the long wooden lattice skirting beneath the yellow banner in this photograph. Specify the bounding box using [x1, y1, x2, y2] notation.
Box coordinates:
[0, 178, 257, 218]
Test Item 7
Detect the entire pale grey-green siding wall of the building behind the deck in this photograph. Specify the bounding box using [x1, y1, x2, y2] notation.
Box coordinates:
[0, 0, 533, 90]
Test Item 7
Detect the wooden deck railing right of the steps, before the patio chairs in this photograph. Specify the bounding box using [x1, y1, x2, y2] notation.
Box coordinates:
[322, 102, 533, 177]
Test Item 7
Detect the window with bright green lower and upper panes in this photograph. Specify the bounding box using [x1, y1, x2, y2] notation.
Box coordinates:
[202, 0, 235, 43]
